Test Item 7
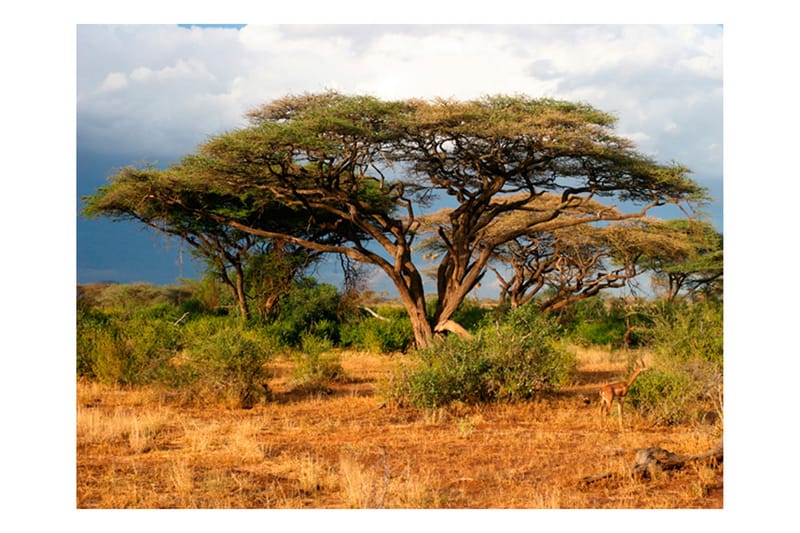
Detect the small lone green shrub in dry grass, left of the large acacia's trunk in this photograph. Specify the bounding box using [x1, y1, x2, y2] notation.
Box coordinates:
[292, 334, 345, 390]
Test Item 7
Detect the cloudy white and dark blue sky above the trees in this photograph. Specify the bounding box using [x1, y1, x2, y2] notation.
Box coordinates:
[76, 24, 724, 290]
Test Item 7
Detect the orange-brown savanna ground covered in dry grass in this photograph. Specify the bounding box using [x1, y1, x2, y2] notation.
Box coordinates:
[77, 349, 723, 509]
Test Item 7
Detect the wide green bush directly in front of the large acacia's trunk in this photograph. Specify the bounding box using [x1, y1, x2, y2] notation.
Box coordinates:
[388, 306, 576, 407]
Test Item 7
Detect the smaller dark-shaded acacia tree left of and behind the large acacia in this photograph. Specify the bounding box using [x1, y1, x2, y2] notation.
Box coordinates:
[83, 167, 318, 320]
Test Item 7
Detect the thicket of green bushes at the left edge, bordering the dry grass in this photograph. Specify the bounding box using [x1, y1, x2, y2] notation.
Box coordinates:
[76, 298, 273, 407]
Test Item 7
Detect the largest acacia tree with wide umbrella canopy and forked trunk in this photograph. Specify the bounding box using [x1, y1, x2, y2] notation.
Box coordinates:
[83, 92, 703, 346]
